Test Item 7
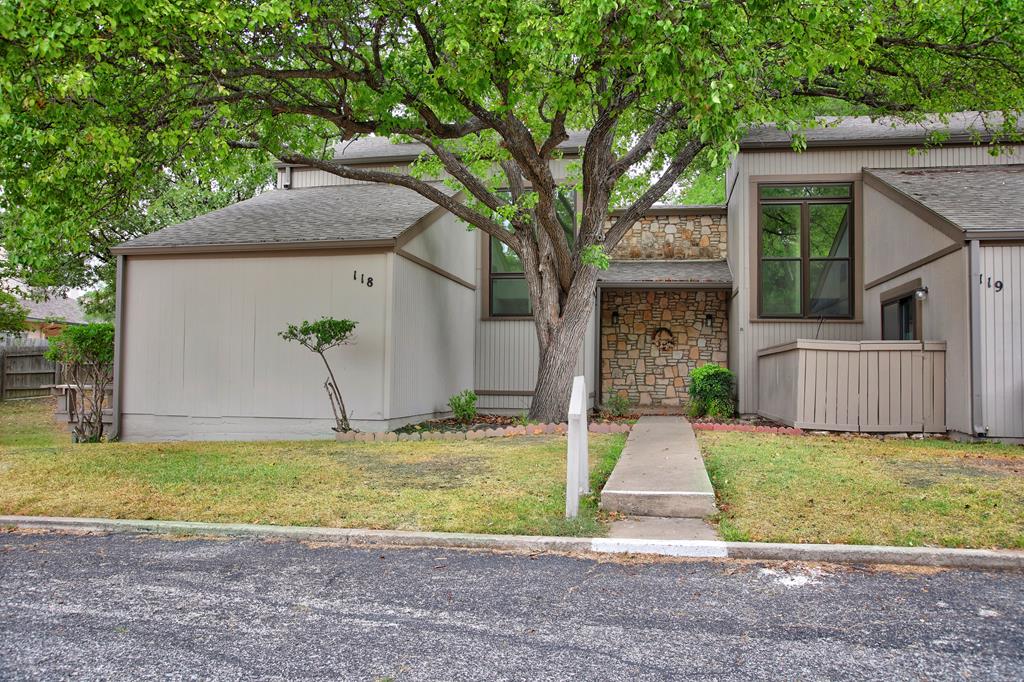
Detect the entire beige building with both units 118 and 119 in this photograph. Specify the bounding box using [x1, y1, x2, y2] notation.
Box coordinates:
[115, 113, 1024, 439]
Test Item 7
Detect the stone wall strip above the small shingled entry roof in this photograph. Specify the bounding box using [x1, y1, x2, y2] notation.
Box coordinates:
[611, 210, 727, 260]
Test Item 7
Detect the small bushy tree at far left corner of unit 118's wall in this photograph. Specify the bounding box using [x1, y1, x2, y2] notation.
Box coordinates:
[46, 324, 114, 442]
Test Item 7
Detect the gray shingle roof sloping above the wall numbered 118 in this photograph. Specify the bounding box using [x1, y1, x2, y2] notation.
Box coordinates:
[111, 182, 455, 252]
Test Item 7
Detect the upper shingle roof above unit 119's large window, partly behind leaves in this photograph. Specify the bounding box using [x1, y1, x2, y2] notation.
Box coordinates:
[739, 112, 1019, 151]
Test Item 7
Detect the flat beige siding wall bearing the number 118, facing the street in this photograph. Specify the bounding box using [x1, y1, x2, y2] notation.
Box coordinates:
[121, 252, 389, 440]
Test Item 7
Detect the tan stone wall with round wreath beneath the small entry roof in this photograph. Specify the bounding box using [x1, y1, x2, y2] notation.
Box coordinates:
[601, 289, 729, 408]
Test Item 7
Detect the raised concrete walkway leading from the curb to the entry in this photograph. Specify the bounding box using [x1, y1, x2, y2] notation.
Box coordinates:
[601, 417, 718, 540]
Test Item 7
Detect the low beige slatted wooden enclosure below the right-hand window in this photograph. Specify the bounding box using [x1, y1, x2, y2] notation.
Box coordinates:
[758, 339, 946, 432]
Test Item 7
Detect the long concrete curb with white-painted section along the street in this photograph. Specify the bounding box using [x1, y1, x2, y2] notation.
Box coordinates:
[0, 516, 1024, 571]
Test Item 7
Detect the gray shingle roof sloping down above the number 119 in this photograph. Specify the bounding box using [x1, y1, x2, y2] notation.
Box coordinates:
[864, 165, 1024, 230]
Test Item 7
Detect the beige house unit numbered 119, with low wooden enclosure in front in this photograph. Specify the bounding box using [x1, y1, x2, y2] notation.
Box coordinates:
[727, 115, 1024, 438]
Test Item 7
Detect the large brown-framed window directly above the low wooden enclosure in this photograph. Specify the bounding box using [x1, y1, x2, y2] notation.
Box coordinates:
[758, 183, 853, 318]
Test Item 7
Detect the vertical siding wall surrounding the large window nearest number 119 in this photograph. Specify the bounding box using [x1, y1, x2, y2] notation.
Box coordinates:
[729, 146, 1024, 413]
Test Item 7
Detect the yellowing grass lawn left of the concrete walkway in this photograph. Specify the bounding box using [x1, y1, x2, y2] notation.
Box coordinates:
[0, 400, 625, 536]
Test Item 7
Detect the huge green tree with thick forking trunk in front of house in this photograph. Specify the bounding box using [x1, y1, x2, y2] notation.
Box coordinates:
[0, 0, 1024, 419]
